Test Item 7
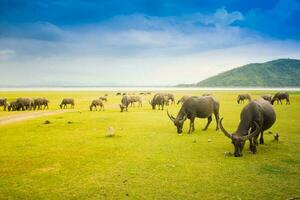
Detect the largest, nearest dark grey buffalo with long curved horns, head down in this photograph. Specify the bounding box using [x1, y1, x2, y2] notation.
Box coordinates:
[220, 99, 276, 157]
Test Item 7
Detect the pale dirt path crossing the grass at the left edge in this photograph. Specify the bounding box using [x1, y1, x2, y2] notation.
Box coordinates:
[0, 110, 68, 125]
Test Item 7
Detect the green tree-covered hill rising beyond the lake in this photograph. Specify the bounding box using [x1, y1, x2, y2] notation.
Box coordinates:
[196, 59, 300, 87]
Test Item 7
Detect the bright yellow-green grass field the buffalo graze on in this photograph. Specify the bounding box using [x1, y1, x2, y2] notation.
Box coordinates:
[0, 91, 300, 200]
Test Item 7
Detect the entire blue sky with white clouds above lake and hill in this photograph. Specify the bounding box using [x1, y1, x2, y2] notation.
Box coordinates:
[0, 0, 300, 85]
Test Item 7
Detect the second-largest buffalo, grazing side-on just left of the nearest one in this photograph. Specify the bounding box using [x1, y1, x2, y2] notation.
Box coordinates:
[167, 96, 220, 134]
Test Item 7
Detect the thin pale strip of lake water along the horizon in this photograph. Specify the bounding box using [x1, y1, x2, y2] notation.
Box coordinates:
[0, 86, 300, 92]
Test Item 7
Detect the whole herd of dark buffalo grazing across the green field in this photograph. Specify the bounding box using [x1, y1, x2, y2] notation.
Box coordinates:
[0, 92, 290, 157]
